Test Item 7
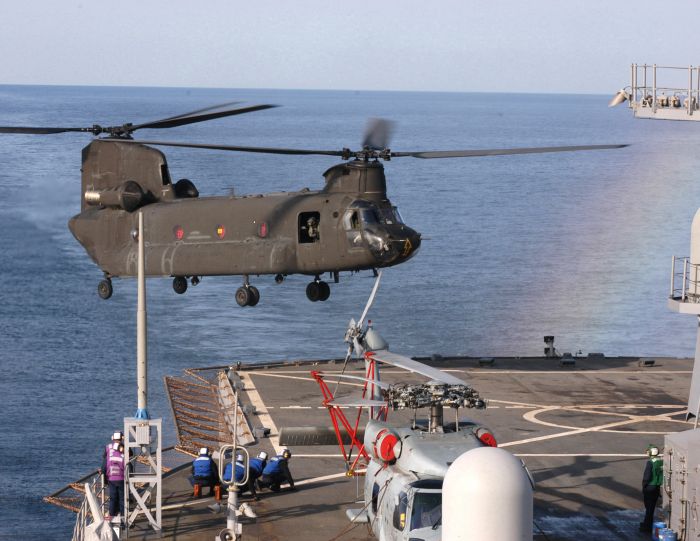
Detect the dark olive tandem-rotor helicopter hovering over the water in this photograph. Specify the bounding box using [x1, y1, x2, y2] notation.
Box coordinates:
[0, 99, 624, 306]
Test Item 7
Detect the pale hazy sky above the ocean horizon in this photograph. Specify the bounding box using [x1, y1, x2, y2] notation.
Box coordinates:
[0, 0, 700, 94]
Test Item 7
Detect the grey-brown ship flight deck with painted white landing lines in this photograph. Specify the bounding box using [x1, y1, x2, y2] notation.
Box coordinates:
[130, 357, 692, 541]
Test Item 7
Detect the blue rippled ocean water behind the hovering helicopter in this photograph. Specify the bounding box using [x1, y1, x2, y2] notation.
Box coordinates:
[0, 86, 700, 539]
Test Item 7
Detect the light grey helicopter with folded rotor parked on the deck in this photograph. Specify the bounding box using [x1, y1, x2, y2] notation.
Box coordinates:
[280, 274, 524, 541]
